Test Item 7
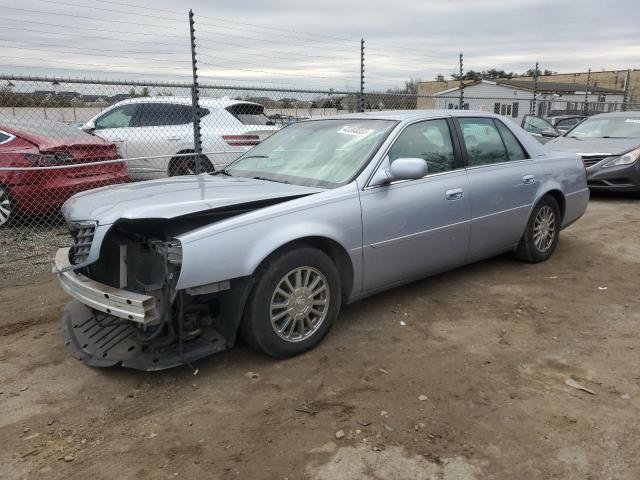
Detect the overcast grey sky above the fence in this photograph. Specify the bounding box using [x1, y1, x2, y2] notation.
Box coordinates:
[0, 0, 640, 89]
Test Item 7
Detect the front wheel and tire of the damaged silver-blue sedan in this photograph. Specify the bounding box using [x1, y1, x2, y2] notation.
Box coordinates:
[241, 247, 341, 358]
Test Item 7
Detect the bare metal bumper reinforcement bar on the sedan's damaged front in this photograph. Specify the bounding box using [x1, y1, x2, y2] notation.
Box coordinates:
[55, 248, 158, 324]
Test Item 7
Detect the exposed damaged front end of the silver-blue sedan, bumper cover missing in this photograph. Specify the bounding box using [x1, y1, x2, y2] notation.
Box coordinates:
[55, 220, 252, 370]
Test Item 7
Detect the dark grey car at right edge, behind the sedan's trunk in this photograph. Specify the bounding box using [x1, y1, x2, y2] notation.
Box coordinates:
[546, 112, 640, 192]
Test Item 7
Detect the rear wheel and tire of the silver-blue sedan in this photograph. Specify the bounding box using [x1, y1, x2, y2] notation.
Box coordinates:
[515, 195, 561, 263]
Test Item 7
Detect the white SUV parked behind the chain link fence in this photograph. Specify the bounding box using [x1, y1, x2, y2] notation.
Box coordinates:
[82, 96, 278, 180]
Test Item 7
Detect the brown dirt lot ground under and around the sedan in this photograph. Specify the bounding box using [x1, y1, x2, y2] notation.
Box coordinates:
[0, 197, 640, 480]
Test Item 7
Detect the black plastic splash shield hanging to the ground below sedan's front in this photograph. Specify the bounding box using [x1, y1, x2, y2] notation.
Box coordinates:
[61, 300, 226, 371]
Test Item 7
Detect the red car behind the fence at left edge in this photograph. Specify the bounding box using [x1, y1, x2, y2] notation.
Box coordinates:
[0, 119, 129, 226]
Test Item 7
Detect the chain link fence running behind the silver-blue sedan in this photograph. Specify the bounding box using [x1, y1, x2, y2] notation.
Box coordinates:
[0, 76, 640, 273]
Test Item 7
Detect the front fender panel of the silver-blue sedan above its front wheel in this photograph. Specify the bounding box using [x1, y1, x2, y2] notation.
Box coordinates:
[176, 184, 362, 290]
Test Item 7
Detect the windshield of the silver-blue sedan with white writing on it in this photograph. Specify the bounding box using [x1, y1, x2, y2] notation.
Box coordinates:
[224, 119, 397, 188]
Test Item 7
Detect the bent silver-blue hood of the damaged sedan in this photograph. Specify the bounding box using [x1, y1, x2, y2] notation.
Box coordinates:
[62, 174, 322, 225]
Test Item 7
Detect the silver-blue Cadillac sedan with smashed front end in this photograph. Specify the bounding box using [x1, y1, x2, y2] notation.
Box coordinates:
[55, 110, 589, 370]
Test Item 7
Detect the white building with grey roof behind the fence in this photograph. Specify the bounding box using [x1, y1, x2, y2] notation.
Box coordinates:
[433, 78, 624, 123]
